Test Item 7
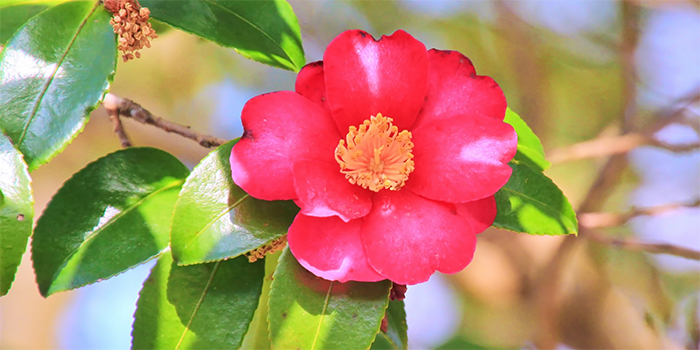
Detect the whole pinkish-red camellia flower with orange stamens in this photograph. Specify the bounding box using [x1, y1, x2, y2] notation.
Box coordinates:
[231, 30, 517, 284]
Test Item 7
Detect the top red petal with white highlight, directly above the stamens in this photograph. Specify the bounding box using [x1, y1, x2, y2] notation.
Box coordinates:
[323, 30, 428, 133]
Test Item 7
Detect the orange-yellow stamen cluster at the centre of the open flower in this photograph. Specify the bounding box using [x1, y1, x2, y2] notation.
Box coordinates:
[335, 113, 415, 192]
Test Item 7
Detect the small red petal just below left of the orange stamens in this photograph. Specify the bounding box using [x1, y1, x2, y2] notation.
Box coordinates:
[292, 159, 372, 222]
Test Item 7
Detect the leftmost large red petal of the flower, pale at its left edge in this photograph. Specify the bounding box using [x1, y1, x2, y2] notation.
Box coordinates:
[231, 91, 340, 200]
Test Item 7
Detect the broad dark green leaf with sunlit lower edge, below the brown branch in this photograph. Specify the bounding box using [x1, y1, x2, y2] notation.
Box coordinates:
[32, 148, 189, 296]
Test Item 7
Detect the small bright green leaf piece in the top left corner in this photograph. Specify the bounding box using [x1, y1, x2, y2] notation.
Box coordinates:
[0, 0, 66, 45]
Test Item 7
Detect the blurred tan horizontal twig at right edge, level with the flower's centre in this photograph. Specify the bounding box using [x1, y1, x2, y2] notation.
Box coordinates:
[548, 133, 700, 163]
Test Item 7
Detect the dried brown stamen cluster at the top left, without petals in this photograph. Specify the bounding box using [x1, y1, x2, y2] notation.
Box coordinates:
[105, 0, 158, 62]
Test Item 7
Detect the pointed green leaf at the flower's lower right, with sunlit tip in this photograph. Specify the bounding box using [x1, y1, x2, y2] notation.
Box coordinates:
[493, 160, 578, 235]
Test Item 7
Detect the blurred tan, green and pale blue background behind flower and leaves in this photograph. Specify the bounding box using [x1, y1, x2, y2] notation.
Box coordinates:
[0, 0, 700, 349]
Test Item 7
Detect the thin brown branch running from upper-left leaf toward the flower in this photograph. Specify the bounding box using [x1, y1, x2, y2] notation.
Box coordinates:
[105, 94, 227, 148]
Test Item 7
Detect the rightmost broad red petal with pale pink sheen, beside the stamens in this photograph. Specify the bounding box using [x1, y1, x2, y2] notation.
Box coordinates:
[406, 116, 518, 203]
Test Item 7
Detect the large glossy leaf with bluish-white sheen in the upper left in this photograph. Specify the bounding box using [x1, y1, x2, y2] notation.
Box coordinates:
[0, 1, 117, 171]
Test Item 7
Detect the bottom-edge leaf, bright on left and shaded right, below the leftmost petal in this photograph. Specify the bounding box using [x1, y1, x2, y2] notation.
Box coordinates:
[132, 253, 265, 349]
